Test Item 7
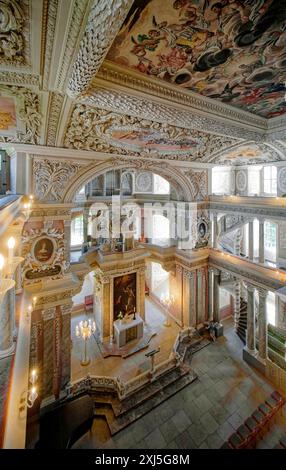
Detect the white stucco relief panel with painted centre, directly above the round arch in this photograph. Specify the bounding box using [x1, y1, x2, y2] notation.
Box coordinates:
[64, 104, 237, 161]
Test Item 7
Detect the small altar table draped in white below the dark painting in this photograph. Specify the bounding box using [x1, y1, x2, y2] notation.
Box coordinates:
[113, 313, 143, 348]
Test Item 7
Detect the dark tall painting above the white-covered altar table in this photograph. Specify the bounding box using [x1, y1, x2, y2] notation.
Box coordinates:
[113, 273, 137, 321]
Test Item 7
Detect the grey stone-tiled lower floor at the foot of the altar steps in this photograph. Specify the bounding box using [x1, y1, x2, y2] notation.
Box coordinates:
[74, 320, 286, 449]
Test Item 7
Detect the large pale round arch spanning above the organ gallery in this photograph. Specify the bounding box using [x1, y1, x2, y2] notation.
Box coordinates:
[62, 158, 197, 203]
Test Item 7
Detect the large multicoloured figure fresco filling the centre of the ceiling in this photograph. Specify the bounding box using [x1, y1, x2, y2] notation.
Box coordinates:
[107, 0, 286, 118]
